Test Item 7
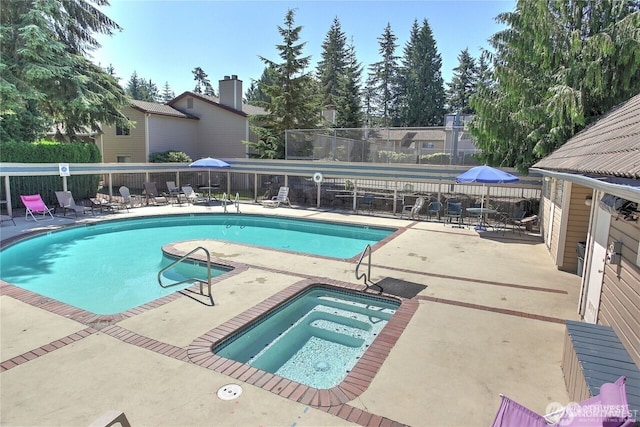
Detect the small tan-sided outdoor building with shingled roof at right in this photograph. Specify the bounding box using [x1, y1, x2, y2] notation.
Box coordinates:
[532, 95, 640, 365]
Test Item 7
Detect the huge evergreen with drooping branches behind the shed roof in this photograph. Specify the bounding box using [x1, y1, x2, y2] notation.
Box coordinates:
[471, 0, 640, 171]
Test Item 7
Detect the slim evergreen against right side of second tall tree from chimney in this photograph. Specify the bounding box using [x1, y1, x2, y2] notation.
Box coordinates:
[335, 41, 363, 128]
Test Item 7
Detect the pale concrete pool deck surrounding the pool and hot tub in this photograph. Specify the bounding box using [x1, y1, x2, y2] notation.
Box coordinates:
[0, 204, 580, 427]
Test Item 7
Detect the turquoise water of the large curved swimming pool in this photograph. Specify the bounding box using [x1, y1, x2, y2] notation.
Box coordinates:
[0, 215, 394, 314]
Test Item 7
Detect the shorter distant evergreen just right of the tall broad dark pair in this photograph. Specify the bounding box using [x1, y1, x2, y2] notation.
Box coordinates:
[447, 49, 478, 114]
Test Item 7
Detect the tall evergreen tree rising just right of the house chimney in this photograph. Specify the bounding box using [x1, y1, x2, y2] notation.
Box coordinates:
[245, 10, 319, 159]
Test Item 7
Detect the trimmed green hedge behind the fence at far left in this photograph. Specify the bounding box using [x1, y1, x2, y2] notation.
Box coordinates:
[0, 141, 101, 207]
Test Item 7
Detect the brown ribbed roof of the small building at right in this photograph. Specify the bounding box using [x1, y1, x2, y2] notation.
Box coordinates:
[533, 94, 640, 180]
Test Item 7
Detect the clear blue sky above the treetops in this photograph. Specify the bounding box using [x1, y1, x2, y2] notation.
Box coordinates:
[92, 0, 515, 95]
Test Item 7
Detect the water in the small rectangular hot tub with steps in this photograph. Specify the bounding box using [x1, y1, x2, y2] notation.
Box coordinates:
[213, 286, 400, 389]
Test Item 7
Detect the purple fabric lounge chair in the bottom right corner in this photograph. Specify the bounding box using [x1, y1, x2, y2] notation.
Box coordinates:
[492, 377, 635, 427]
